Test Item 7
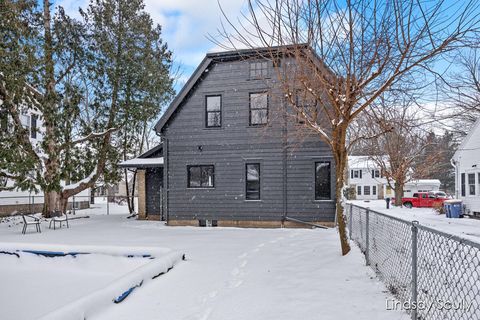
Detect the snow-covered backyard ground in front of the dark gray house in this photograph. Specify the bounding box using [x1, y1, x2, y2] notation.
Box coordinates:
[0, 205, 409, 320]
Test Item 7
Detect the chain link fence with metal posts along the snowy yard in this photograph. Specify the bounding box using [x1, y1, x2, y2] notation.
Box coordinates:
[346, 204, 480, 320]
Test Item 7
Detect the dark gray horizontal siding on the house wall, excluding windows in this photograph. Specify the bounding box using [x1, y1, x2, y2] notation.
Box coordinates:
[157, 48, 335, 224]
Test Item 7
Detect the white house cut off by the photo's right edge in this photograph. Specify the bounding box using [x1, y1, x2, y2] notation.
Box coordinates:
[452, 118, 480, 215]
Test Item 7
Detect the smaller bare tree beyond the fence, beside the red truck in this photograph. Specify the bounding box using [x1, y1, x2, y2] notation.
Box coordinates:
[356, 99, 441, 206]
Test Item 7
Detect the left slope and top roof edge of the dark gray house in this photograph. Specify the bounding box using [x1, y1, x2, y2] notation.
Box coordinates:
[155, 44, 318, 133]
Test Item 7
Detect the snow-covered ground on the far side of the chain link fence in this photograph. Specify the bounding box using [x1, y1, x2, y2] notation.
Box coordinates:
[350, 200, 480, 243]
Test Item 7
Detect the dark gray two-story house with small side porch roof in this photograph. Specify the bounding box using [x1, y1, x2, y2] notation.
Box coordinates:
[122, 45, 336, 227]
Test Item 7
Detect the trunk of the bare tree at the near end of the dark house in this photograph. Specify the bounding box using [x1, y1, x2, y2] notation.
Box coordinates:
[332, 127, 350, 255]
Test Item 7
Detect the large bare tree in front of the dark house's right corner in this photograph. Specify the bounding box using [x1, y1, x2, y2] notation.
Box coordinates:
[211, 0, 480, 254]
